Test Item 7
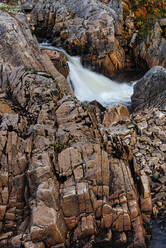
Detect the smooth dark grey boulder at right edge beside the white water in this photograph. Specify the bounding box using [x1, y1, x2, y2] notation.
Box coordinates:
[131, 66, 166, 111]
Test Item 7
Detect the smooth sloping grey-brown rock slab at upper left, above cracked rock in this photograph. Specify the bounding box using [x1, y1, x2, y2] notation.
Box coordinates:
[0, 11, 68, 83]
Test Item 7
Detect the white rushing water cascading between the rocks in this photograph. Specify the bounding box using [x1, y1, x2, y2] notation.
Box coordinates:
[41, 43, 133, 107]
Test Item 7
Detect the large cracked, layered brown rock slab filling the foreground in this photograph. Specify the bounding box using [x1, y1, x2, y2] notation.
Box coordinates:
[1, 68, 147, 247]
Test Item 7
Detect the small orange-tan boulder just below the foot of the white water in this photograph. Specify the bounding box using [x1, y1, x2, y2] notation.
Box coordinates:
[103, 105, 129, 127]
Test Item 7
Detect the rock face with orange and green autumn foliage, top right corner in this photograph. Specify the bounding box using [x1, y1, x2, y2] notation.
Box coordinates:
[120, 0, 166, 70]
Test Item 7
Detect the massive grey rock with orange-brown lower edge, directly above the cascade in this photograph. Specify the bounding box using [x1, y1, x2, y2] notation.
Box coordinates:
[31, 0, 125, 76]
